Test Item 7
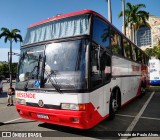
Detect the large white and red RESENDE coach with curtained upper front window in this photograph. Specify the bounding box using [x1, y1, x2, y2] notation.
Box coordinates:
[15, 10, 149, 129]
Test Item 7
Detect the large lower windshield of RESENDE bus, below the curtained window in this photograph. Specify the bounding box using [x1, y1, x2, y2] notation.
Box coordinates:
[16, 40, 86, 90]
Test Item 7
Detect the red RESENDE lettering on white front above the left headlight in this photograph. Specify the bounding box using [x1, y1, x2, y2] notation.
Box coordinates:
[16, 92, 36, 99]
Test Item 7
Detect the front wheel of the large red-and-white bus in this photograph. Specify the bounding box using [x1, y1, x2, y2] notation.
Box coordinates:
[109, 89, 120, 120]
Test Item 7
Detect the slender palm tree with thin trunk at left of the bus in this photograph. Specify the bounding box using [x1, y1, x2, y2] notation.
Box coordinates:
[0, 27, 23, 87]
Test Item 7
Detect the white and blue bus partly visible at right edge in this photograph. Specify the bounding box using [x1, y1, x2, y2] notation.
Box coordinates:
[149, 59, 160, 86]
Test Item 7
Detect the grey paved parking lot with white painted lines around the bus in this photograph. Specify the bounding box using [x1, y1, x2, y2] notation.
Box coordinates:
[0, 83, 160, 140]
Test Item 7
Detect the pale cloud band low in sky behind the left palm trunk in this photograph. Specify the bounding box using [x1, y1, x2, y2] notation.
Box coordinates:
[0, 48, 20, 62]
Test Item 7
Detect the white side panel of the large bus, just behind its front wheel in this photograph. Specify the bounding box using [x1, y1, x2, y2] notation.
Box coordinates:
[112, 56, 141, 105]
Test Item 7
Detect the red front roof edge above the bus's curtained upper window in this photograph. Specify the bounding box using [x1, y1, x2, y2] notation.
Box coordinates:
[28, 10, 106, 28]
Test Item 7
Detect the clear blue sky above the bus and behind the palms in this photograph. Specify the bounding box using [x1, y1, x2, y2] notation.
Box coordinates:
[0, 0, 160, 61]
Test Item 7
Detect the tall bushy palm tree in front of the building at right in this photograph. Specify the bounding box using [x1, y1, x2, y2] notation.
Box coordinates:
[118, 2, 149, 41]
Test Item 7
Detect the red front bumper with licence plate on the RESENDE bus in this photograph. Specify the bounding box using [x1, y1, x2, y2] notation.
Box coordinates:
[16, 103, 107, 129]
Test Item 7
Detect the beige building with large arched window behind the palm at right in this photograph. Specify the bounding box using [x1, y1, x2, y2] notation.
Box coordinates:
[126, 15, 160, 50]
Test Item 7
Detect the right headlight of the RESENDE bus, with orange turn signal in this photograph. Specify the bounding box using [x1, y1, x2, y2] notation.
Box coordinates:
[61, 103, 86, 111]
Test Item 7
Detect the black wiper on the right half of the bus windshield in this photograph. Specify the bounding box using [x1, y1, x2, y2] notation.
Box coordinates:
[44, 70, 62, 94]
